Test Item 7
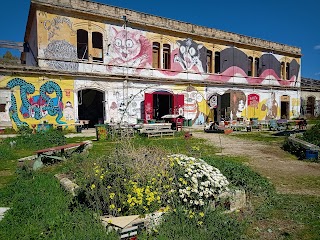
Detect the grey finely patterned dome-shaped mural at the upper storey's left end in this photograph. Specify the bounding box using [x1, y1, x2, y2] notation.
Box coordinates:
[44, 40, 79, 71]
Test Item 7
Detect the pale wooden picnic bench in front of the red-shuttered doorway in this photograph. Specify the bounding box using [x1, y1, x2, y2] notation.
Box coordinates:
[139, 123, 176, 138]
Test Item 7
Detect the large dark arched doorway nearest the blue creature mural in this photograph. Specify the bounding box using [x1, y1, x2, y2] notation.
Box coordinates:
[78, 89, 104, 127]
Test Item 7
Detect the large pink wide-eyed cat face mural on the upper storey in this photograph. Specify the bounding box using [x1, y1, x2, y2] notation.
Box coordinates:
[107, 27, 152, 71]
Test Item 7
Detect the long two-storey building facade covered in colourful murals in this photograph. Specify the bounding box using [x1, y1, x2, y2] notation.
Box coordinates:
[0, 0, 301, 126]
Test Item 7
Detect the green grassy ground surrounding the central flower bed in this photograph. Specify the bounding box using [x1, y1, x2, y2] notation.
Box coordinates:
[0, 132, 320, 239]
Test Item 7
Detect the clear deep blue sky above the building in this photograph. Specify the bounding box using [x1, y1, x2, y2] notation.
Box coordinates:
[0, 0, 320, 80]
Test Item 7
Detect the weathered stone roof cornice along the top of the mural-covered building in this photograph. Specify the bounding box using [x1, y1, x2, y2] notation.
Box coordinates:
[26, 0, 301, 57]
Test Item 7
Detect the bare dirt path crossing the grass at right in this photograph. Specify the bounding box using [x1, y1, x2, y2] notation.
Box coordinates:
[192, 132, 320, 196]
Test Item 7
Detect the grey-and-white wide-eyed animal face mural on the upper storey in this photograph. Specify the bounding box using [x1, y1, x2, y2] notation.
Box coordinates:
[173, 38, 207, 73]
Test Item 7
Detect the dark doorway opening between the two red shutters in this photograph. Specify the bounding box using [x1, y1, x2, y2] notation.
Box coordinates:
[153, 92, 173, 120]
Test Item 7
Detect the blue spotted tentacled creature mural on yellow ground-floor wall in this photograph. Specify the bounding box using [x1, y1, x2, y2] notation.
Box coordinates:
[7, 78, 65, 126]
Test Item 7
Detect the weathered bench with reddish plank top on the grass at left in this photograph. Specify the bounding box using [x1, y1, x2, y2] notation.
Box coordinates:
[32, 142, 87, 170]
